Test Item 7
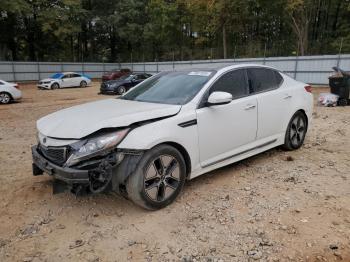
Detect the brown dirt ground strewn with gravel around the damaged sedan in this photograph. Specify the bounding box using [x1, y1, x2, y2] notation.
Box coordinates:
[0, 83, 350, 262]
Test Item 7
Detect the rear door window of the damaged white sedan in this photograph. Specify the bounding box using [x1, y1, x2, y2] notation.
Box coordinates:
[248, 68, 279, 93]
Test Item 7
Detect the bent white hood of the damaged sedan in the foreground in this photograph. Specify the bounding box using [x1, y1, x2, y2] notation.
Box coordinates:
[37, 99, 181, 139]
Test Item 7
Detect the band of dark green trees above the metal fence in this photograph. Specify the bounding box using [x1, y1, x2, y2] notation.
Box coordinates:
[0, 0, 350, 62]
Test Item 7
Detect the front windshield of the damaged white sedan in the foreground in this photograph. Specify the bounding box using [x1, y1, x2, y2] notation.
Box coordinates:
[121, 71, 215, 105]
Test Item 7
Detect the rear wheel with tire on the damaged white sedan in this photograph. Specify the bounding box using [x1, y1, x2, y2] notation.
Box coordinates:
[283, 111, 307, 151]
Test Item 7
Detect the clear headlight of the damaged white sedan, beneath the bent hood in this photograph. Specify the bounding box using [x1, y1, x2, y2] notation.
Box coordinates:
[66, 128, 130, 166]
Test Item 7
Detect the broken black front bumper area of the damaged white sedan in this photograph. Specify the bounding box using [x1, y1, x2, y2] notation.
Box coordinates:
[32, 146, 143, 194]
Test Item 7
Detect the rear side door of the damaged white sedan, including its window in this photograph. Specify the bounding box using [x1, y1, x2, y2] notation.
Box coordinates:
[247, 67, 293, 140]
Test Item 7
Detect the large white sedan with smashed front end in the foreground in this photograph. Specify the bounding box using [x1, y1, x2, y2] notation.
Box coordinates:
[32, 65, 313, 209]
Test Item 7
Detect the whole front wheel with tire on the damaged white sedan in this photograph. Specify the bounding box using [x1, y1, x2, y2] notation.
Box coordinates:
[126, 145, 186, 210]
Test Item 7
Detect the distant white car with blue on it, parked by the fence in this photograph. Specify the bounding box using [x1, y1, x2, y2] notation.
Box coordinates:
[37, 72, 91, 89]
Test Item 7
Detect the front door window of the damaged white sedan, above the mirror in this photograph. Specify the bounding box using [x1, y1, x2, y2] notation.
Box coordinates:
[210, 70, 248, 98]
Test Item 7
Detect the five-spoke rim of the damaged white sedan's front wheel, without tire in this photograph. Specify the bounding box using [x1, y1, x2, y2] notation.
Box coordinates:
[144, 155, 180, 202]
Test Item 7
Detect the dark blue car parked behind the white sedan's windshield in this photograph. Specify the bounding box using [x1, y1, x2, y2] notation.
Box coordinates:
[100, 73, 152, 95]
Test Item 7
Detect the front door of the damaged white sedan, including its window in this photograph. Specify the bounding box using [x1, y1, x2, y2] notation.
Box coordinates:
[197, 69, 258, 167]
